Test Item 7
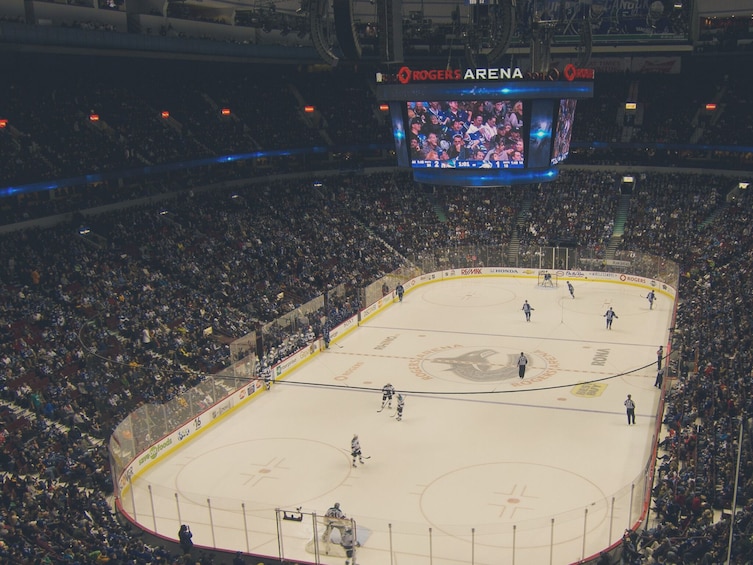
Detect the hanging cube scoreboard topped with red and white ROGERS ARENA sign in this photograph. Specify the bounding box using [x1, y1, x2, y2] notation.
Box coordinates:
[377, 65, 594, 186]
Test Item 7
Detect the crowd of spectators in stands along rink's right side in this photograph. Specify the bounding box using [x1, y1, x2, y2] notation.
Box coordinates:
[608, 178, 753, 565]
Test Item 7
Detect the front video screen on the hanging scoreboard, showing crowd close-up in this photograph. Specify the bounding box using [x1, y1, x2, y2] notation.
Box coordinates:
[407, 100, 525, 169]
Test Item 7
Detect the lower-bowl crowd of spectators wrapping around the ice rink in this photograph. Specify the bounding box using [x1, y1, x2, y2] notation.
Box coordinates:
[0, 165, 753, 563]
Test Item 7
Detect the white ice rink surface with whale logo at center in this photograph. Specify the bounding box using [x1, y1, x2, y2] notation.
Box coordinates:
[123, 277, 673, 565]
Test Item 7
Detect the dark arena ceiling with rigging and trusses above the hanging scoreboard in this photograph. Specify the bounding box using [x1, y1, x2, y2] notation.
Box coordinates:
[164, 0, 753, 64]
